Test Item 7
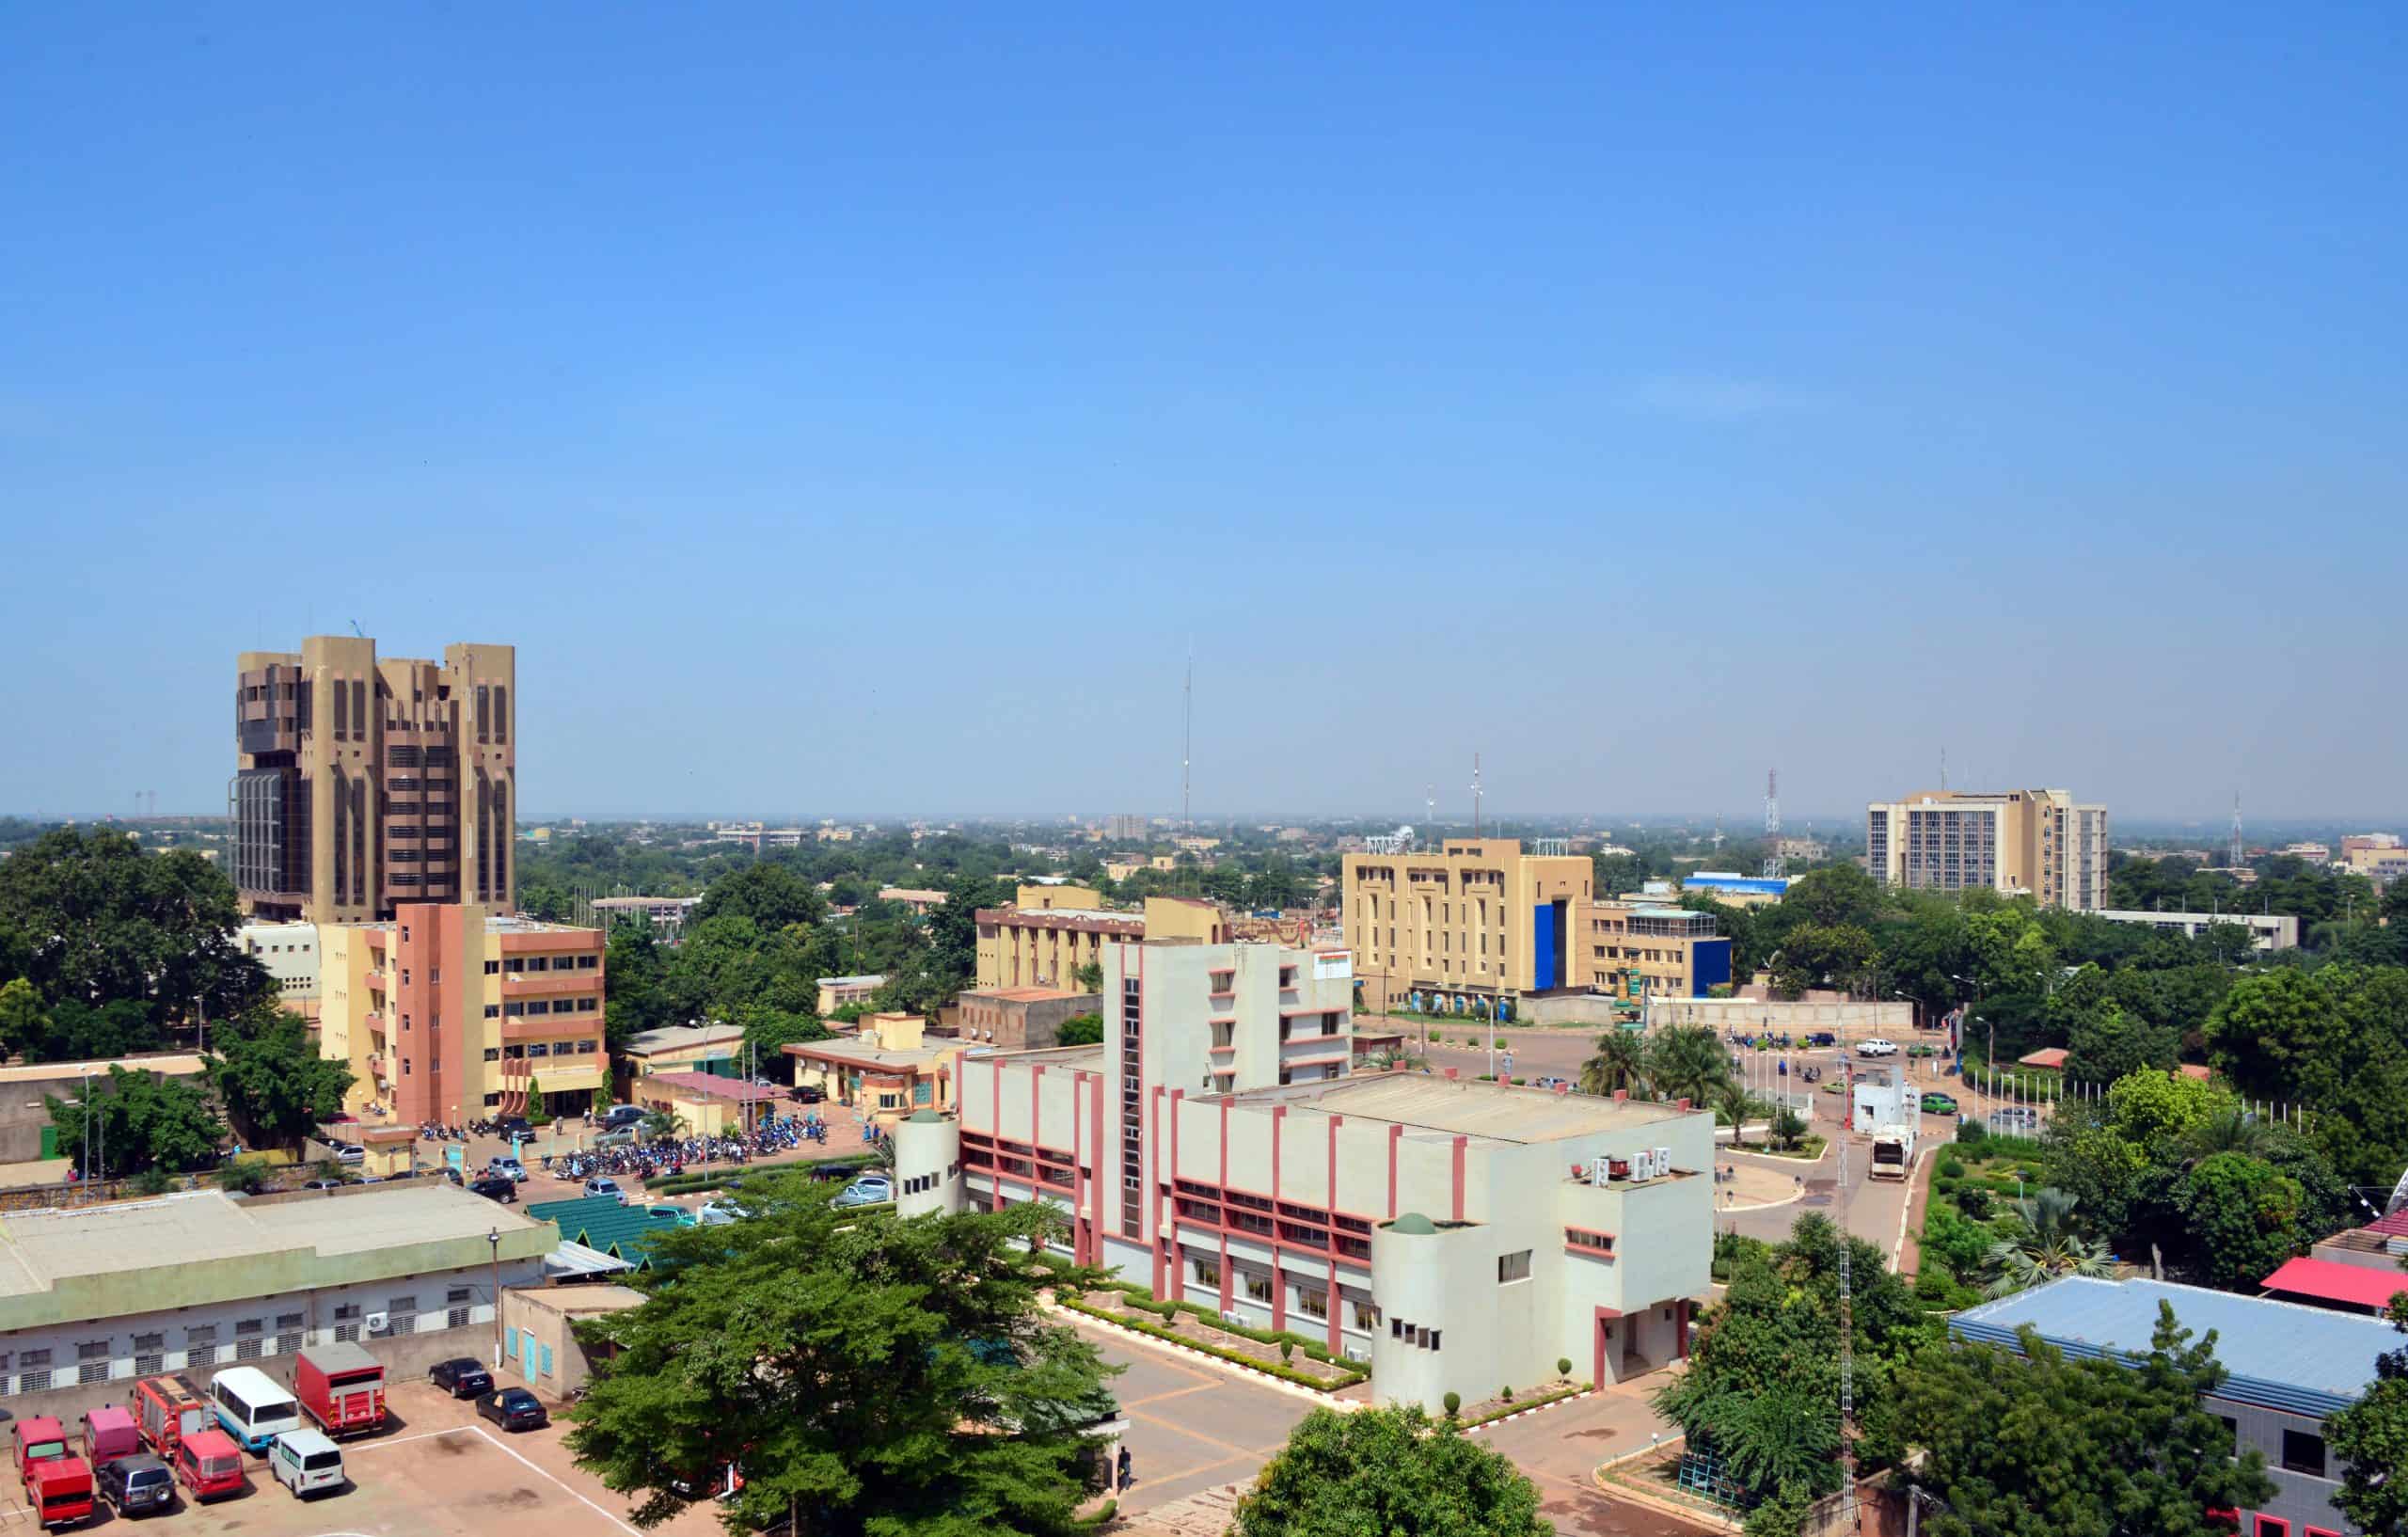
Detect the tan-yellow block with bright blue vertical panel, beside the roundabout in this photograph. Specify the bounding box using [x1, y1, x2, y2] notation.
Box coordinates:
[1339, 838, 1594, 1012]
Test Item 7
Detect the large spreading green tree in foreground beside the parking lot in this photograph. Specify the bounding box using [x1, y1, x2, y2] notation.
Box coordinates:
[568, 1173, 1115, 1537]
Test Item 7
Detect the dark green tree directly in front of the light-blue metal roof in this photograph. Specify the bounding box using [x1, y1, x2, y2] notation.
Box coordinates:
[1900, 1304, 2273, 1537]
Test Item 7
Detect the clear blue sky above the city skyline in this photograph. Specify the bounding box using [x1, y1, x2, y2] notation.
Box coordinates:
[0, 5, 2408, 815]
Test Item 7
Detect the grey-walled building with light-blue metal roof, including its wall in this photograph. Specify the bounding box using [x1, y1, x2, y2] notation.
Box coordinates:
[1948, 1276, 2400, 1537]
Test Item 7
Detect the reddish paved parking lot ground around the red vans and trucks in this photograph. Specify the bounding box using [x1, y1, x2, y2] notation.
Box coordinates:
[0, 1383, 720, 1537]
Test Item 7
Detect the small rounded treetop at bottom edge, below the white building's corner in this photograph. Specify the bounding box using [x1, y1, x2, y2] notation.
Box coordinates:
[1233, 1404, 1553, 1537]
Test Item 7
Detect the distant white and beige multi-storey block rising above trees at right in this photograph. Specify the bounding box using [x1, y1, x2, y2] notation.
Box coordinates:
[1863, 790, 2107, 913]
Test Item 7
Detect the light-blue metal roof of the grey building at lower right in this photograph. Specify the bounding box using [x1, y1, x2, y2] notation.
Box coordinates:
[1948, 1276, 2400, 1419]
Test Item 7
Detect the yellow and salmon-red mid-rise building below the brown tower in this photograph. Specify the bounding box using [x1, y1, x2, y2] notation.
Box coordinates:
[318, 903, 610, 1125]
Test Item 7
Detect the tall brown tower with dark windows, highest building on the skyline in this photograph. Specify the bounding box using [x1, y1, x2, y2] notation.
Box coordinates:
[227, 636, 517, 923]
